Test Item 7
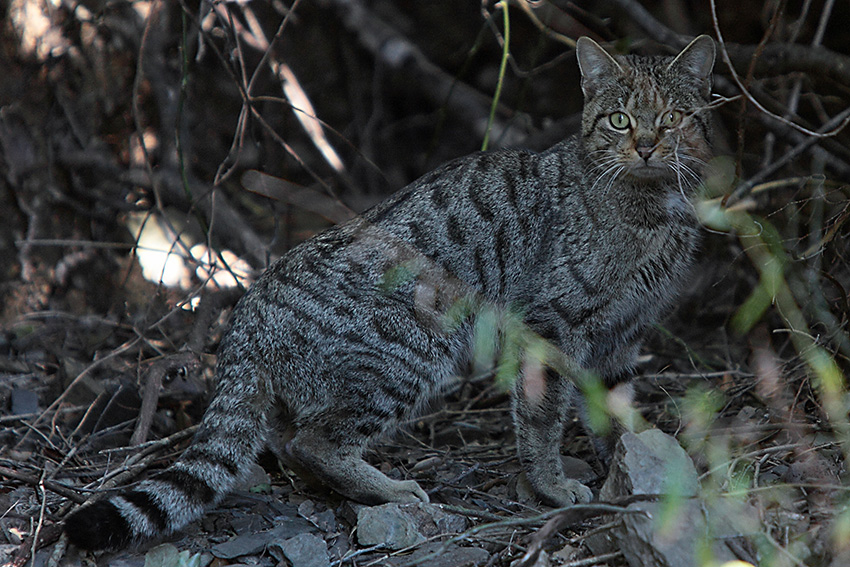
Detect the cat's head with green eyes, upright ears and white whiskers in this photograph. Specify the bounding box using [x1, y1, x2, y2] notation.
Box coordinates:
[576, 35, 715, 188]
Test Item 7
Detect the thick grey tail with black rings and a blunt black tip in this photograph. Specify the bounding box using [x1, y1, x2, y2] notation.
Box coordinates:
[64, 363, 266, 550]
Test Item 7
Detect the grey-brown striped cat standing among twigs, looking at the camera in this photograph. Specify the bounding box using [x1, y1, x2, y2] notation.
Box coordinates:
[65, 36, 715, 549]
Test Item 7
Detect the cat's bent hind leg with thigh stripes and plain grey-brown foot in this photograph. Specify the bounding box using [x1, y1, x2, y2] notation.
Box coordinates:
[284, 342, 446, 504]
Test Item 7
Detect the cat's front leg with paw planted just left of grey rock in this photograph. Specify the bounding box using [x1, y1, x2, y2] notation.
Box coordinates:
[513, 367, 593, 506]
